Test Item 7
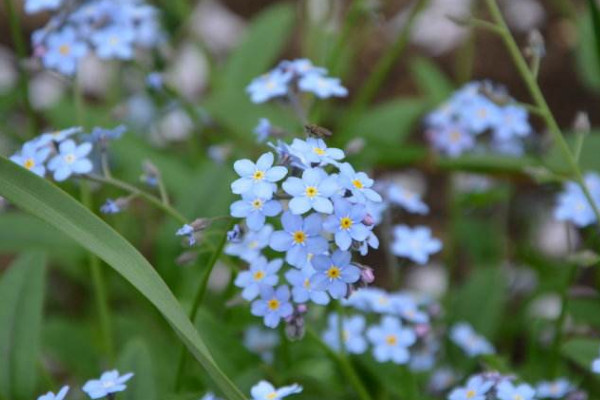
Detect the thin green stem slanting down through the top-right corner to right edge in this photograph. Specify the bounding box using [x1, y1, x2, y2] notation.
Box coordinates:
[486, 0, 600, 222]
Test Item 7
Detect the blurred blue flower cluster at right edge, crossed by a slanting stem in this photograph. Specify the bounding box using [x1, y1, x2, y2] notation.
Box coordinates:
[554, 172, 600, 227]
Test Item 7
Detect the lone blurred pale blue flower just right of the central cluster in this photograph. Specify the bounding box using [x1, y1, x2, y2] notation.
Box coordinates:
[392, 225, 442, 264]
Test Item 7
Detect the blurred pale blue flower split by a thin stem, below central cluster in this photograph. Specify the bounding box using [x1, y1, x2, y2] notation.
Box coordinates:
[323, 313, 368, 354]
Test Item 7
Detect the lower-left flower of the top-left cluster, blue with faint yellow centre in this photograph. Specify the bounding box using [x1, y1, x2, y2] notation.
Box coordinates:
[42, 26, 88, 75]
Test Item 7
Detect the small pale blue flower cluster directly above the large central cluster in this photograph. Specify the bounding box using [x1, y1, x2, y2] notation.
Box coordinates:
[246, 58, 348, 104]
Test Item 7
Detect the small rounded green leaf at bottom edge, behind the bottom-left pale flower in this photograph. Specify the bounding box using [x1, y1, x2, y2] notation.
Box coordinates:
[117, 339, 158, 400]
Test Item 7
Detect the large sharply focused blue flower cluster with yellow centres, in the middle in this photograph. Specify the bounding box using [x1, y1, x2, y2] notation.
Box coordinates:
[226, 138, 382, 327]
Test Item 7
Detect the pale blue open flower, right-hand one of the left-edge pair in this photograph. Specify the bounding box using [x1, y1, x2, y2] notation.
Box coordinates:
[48, 140, 93, 182]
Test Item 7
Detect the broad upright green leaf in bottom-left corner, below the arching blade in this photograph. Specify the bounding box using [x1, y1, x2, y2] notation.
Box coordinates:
[0, 252, 46, 400]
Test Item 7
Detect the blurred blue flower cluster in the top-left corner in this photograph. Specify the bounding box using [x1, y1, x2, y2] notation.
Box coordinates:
[25, 0, 162, 75]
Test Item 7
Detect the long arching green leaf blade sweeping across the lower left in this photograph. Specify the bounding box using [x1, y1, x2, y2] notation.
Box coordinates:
[0, 158, 244, 400]
